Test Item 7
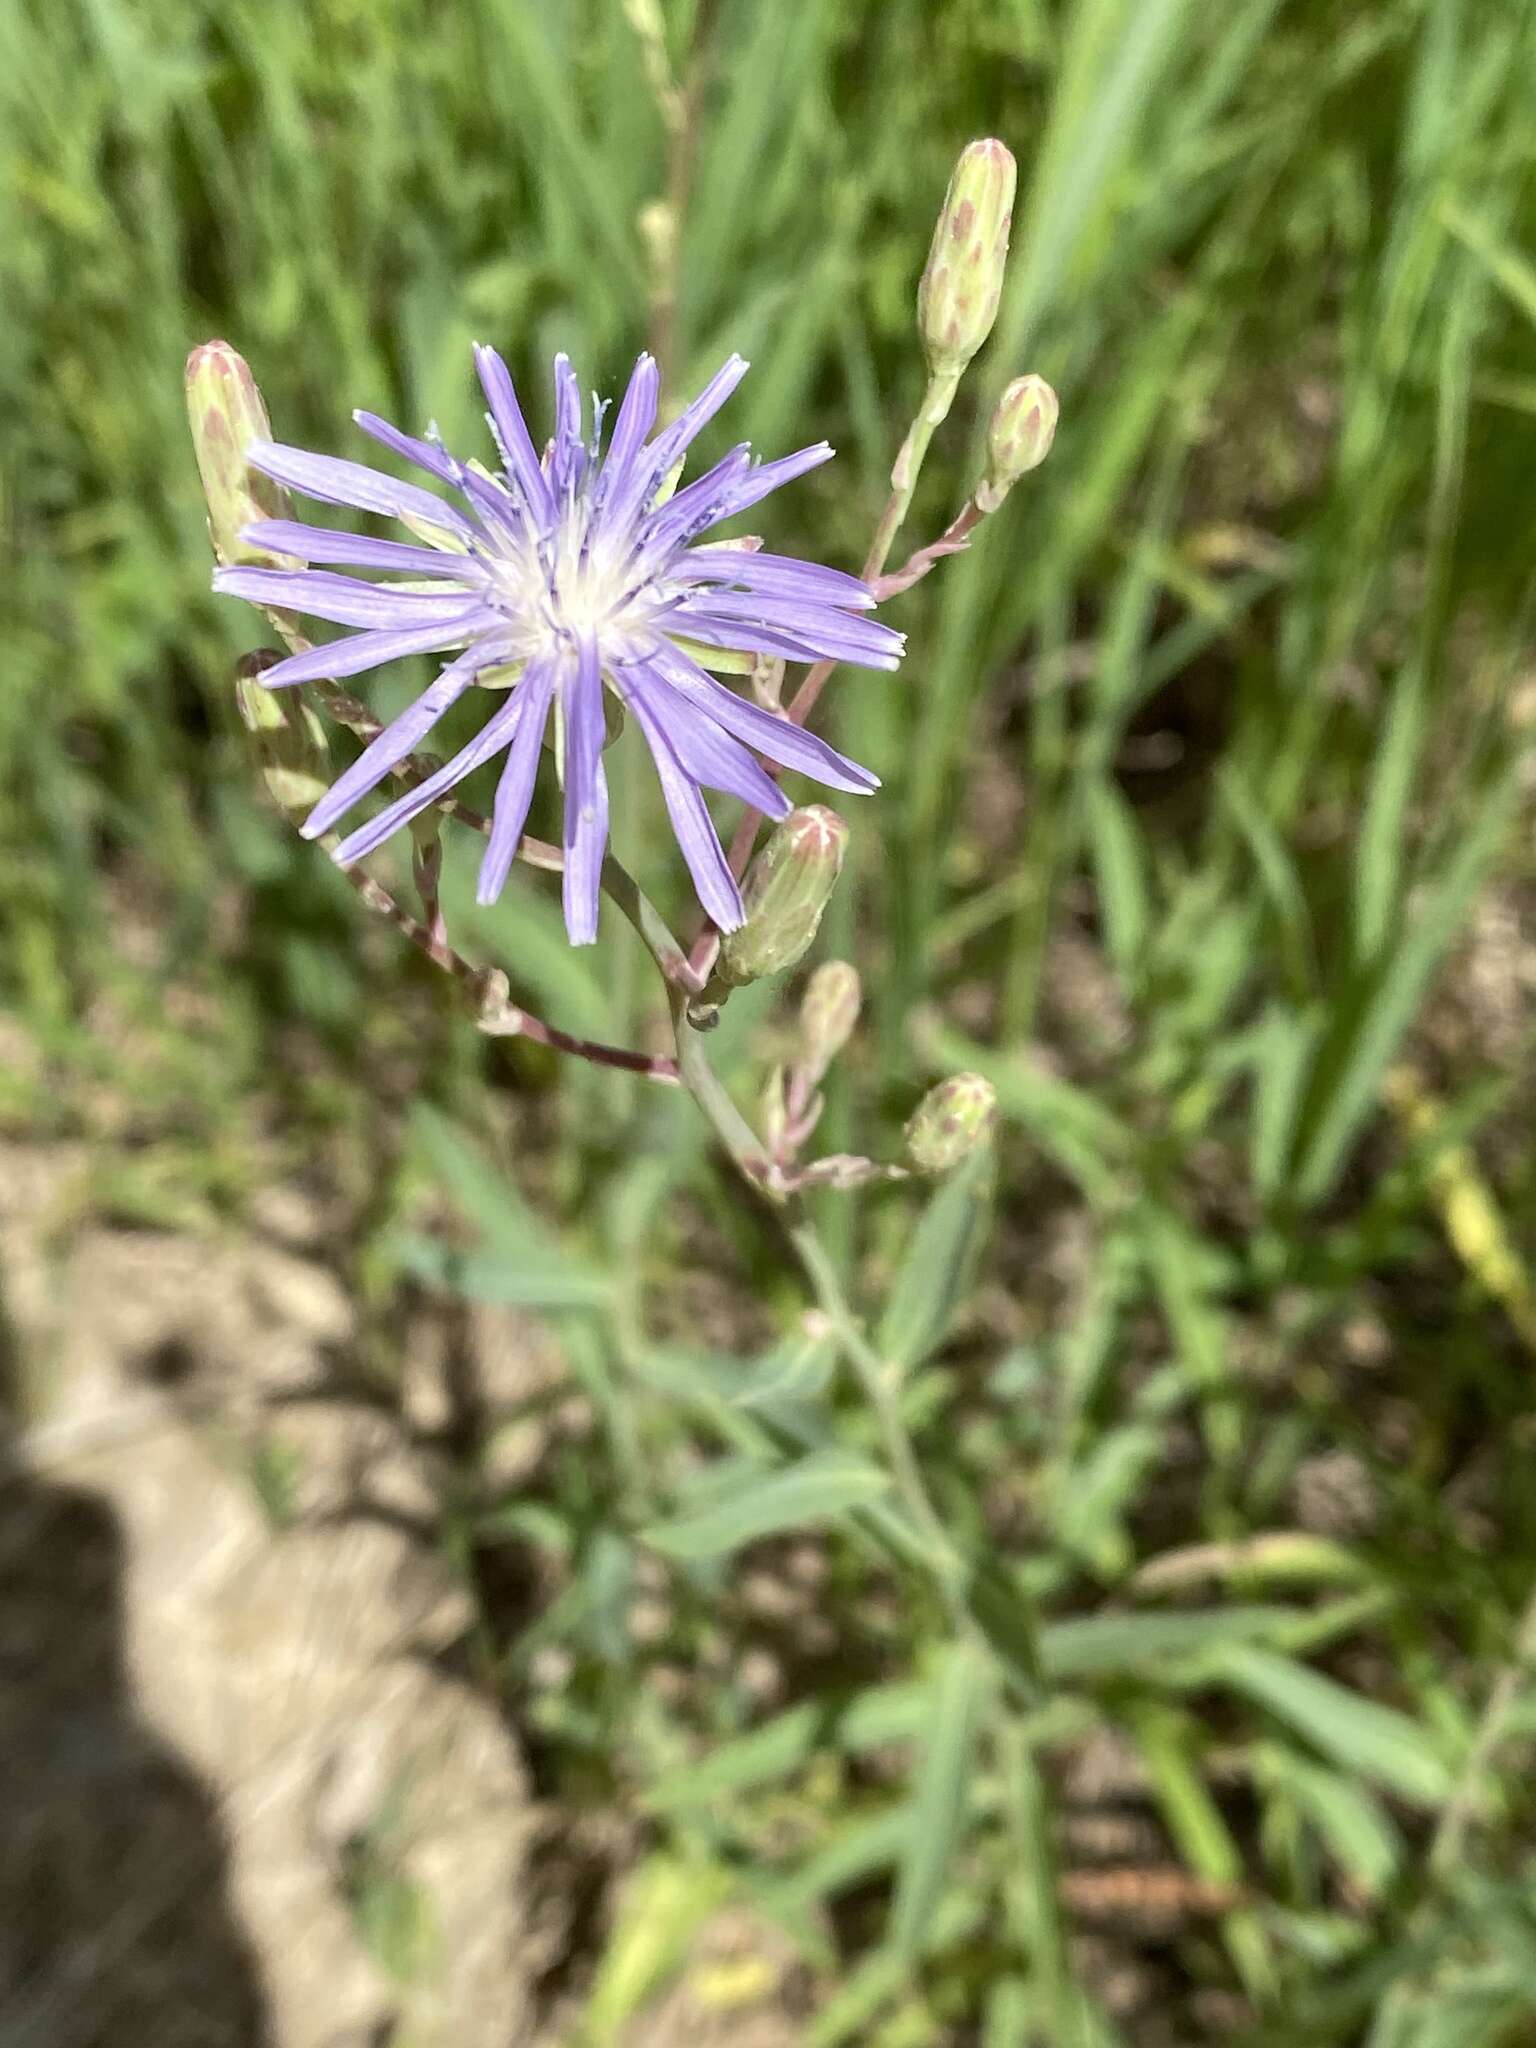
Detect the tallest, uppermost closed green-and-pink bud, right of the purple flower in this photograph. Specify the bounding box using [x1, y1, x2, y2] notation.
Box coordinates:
[918, 139, 1018, 377]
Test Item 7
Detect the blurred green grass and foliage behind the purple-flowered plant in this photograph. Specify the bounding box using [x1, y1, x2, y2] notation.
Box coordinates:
[0, 0, 1536, 2048]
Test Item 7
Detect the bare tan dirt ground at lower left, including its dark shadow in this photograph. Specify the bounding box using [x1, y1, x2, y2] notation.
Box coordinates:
[0, 1149, 548, 2048]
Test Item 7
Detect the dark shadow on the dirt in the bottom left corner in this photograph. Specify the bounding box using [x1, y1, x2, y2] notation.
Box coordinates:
[0, 1307, 272, 2048]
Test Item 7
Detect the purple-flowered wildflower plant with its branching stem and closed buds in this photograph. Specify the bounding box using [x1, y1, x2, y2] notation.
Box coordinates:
[186, 141, 1057, 1982]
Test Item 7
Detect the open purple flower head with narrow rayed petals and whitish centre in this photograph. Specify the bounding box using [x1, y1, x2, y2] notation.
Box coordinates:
[213, 348, 903, 946]
